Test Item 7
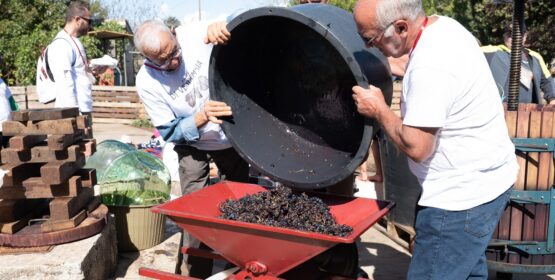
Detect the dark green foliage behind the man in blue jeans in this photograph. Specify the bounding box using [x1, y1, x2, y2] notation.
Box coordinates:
[289, 0, 555, 62]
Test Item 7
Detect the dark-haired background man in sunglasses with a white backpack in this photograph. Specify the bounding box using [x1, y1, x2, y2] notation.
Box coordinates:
[47, 1, 95, 131]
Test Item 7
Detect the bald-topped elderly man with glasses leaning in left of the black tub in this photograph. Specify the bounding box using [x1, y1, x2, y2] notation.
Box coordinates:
[135, 20, 249, 279]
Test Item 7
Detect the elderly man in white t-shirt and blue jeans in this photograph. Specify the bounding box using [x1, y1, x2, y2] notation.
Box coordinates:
[353, 0, 518, 280]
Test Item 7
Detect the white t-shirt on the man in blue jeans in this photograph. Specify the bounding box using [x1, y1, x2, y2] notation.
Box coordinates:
[401, 17, 518, 211]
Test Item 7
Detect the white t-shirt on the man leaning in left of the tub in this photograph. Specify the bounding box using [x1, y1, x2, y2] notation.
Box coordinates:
[136, 23, 231, 151]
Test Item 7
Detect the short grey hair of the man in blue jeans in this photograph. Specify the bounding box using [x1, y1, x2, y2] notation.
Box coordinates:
[376, 0, 425, 30]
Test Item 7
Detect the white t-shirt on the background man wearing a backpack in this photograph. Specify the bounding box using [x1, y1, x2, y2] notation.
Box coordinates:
[48, 30, 93, 112]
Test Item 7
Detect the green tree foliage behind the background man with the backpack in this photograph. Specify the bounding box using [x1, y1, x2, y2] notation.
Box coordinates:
[0, 0, 130, 85]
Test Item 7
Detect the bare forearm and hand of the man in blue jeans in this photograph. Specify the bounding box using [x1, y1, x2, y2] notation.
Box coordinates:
[353, 86, 438, 162]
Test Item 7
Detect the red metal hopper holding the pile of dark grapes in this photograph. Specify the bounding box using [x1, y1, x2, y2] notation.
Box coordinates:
[146, 181, 393, 277]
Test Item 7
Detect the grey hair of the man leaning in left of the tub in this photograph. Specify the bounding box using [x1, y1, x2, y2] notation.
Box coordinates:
[133, 19, 171, 55]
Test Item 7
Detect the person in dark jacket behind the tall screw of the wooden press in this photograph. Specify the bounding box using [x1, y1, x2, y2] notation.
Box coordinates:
[482, 24, 555, 104]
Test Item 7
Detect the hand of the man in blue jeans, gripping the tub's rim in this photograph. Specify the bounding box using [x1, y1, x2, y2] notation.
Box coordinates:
[353, 85, 387, 119]
